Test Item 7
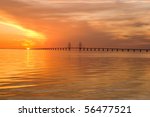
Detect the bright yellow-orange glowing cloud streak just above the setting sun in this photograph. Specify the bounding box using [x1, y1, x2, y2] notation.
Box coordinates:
[0, 13, 46, 47]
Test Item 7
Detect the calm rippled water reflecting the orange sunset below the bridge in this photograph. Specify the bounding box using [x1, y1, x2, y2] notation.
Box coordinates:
[0, 50, 150, 99]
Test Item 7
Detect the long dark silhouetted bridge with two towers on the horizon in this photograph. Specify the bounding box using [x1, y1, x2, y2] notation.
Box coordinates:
[32, 42, 150, 52]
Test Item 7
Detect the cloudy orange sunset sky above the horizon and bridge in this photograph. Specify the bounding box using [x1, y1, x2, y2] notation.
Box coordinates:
[0, 0, 150, 48]
